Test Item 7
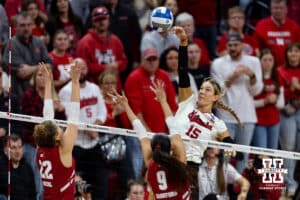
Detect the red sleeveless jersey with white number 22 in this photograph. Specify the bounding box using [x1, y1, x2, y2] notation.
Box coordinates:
[36, 147, 75, 200]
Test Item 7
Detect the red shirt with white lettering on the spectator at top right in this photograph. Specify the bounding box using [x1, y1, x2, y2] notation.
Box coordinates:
[255, 17, 300, 66]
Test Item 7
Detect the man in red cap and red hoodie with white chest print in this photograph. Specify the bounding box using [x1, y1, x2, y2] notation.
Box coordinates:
[77, 6, 127, 89]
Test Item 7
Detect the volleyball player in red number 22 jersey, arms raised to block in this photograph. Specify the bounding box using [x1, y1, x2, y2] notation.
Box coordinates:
[33, 63, 81, 200]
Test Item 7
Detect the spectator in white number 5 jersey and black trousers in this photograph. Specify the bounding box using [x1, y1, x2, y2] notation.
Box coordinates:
[59, 58, 108, 199]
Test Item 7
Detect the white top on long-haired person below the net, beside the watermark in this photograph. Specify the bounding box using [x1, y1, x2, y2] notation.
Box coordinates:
[198, 161, 242, 200]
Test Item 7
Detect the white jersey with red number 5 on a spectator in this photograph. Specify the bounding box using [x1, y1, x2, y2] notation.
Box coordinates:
[59, 81, 107, 149]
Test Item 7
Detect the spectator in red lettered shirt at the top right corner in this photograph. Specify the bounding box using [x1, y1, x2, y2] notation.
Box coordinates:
[255, 0, 300, 66]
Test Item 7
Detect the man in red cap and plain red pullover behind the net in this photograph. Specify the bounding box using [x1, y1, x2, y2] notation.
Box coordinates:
[125, 48, 177, 177]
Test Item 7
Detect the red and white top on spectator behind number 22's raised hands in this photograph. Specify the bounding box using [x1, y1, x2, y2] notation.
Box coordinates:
[49, 52, 73, 80]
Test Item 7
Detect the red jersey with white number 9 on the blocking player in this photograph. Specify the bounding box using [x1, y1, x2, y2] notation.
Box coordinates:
[147, 160, 191, 200]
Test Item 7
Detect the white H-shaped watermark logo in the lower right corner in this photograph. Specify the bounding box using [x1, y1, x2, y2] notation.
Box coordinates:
[258, 158, 288, 183]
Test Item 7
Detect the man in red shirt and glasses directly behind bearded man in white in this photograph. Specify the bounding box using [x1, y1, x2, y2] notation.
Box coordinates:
[217, 6, 259, 56]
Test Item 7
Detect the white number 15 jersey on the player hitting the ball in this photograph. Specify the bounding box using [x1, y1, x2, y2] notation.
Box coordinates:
[173, 95, 227, 163]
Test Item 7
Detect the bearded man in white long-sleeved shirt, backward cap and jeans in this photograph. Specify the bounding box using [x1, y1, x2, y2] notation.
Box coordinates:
[210, 32, 263, 172]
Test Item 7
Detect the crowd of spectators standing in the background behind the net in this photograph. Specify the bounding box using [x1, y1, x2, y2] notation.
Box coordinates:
[0, 0, 300, 199]
